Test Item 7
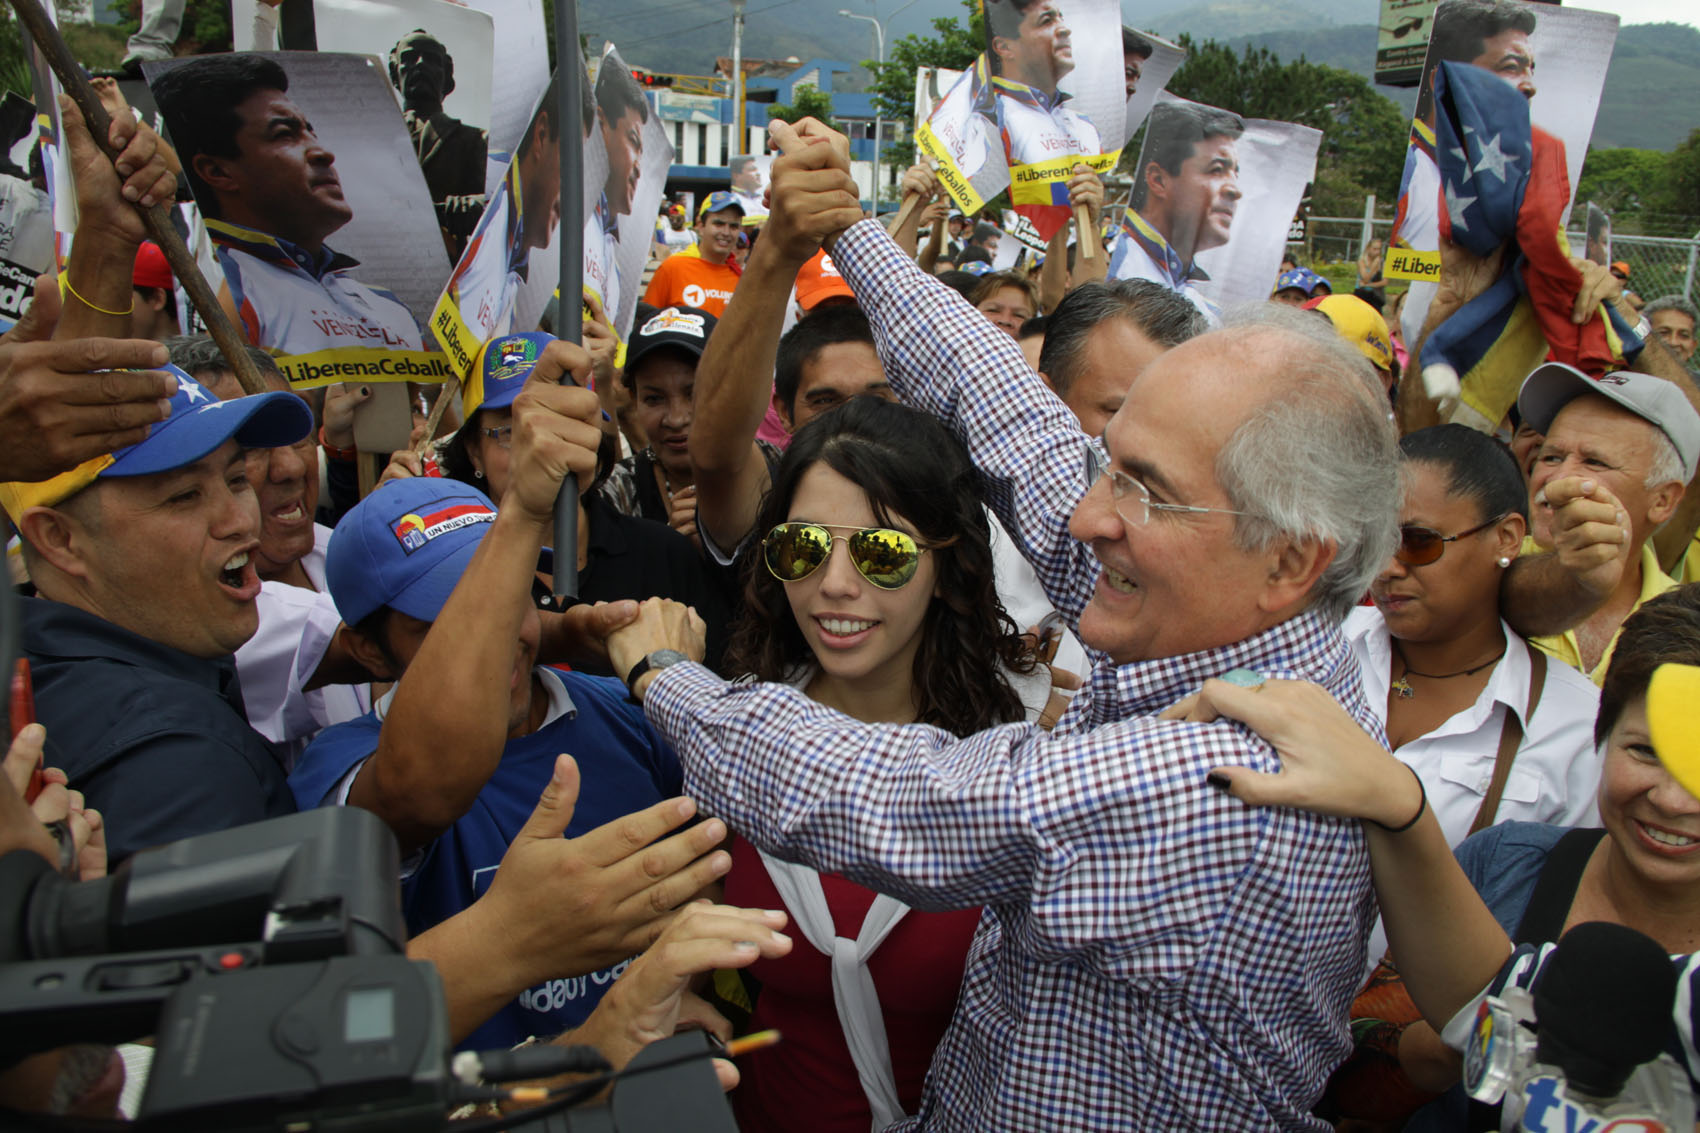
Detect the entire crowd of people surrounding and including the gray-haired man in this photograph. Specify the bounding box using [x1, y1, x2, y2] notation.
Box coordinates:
[0, 54, 1700, 1133]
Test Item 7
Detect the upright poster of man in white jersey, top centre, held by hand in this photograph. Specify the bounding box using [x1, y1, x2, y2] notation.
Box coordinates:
[981, 0, 1127, 240]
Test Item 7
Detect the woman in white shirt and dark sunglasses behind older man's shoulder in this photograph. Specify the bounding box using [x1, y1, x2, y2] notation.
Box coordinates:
[1345, 425, 1600, 845]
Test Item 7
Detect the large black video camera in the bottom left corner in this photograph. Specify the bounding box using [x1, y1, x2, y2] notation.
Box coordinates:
[0, 806, 736, 1133]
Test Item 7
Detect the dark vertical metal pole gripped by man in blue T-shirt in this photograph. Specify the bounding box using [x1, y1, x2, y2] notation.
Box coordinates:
[557, 0, 585, 606]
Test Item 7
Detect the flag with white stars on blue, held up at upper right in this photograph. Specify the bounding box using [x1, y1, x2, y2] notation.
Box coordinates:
[1421, 63, 1641, 422]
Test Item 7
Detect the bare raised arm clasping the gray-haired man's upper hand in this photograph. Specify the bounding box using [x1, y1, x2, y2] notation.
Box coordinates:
[690, 134, 862, 551]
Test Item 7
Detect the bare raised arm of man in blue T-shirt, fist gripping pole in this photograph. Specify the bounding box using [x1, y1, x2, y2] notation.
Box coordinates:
[349, 342, 602, 852]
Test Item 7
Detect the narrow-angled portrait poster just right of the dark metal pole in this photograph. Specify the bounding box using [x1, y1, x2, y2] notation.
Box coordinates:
[585, 44, 680, 339]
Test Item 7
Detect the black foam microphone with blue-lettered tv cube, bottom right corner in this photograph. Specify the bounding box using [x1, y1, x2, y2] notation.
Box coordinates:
[1464, 922, 1695, 1133]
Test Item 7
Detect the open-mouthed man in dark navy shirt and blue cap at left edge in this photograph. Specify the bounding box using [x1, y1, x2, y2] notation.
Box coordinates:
[0, 366, 313, 864]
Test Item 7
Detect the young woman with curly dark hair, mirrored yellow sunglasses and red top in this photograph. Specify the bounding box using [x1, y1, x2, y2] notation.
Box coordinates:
[724, 396, 1051, 1133]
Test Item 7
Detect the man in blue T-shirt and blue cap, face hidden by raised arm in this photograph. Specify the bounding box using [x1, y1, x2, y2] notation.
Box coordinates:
[289, 344, 729, 1050]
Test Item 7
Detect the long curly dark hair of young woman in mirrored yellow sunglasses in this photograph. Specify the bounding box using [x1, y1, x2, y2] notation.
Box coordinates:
[724, 396, 1035, 737]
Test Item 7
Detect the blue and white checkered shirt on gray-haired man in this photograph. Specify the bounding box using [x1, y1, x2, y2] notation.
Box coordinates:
[646, 221, 1380, 1133]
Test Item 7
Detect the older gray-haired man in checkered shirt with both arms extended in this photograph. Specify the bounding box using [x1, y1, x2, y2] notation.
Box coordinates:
[610, 121, 1399, 1131]
